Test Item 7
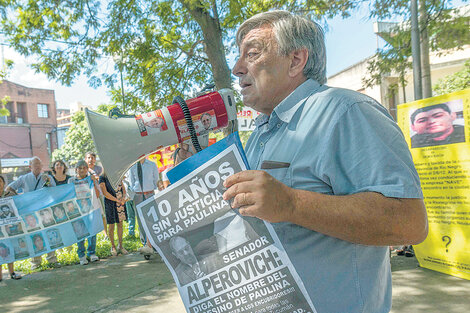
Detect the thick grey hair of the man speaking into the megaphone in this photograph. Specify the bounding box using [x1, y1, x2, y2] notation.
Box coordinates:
[236, 10, 326, 84]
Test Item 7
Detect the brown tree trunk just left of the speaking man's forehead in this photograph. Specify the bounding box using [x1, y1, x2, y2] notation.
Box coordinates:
[182, 1, 232, 89]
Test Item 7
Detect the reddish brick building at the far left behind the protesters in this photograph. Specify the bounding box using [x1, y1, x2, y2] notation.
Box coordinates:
[0, 80, 57, 180]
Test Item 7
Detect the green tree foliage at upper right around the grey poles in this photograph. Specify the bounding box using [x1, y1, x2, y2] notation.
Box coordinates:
[363, 0, 470, 100]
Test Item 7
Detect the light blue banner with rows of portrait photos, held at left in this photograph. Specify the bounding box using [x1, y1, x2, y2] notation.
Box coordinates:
[0, 178, 103, 264]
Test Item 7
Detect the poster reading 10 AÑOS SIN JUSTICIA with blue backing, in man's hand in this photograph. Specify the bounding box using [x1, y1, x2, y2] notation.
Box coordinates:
[137, 134, 316, 313]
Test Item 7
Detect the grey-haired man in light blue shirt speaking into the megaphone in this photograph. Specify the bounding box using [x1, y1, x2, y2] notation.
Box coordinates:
[224, 11, 427, 313]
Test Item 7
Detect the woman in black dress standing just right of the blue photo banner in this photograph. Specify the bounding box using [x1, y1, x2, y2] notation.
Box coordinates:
[99, 172, 128, 256]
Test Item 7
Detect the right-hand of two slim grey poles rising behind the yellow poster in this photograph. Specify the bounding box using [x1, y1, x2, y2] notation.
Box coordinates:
[419, 0, 432, 98]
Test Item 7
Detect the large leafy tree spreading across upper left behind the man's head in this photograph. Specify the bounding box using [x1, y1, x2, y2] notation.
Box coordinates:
[0, 0, 361, 111]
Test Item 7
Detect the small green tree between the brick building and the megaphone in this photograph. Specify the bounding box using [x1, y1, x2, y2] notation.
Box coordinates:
[51, 104, 116, 165]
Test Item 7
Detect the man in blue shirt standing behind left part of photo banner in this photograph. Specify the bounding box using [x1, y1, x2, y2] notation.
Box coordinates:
[6, 156, 60, 270]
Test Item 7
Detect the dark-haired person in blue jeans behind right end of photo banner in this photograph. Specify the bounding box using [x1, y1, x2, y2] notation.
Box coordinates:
[68, 160, 99, 265]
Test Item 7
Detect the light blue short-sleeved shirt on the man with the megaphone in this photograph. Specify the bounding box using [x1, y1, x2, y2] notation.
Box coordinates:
[246, 79, 422, 313]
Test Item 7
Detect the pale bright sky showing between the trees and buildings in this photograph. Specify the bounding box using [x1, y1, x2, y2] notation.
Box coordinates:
[0, 1, 461, 108]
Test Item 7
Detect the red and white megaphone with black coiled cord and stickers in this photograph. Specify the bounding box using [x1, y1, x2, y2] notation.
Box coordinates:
[85, 89, 237, 187]
